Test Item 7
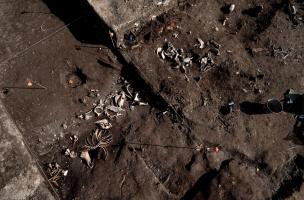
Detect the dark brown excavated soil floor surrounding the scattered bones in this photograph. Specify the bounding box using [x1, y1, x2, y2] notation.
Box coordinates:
[0, 0, 304, 200]
